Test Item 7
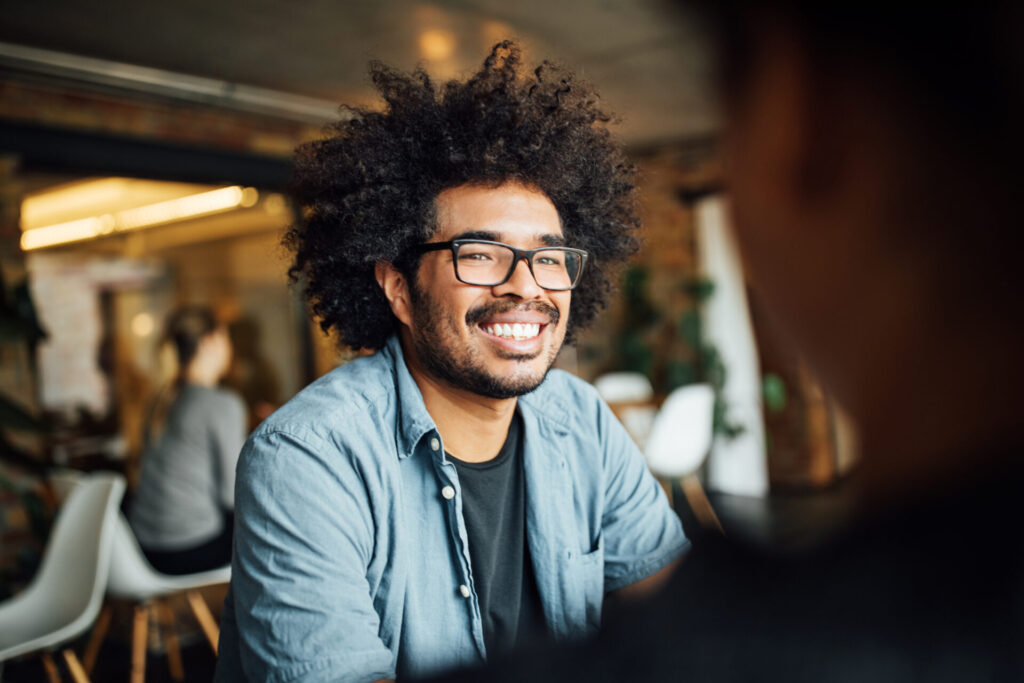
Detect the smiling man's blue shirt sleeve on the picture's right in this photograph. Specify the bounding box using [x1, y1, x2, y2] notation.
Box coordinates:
[598, 399, 690, 592]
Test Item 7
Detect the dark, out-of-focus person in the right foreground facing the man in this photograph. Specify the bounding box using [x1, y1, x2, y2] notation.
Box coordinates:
[428, 1, 1024, 683]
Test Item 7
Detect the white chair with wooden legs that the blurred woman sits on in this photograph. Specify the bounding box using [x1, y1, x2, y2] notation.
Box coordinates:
[83, 514, 231, 683]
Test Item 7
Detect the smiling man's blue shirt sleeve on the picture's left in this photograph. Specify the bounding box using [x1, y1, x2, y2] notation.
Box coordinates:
[231, 432, 395, 682]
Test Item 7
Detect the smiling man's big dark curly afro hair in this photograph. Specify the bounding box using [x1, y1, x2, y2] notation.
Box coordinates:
[285, 41, 639, 349]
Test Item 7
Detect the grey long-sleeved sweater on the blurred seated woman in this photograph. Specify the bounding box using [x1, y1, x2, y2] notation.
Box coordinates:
[128, 384, 247, 551]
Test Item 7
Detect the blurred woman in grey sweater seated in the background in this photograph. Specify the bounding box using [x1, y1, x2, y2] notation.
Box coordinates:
[128, 306, 246, 574]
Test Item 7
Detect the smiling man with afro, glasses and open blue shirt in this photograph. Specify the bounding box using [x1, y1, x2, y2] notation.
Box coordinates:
[217, 43, 688, 681]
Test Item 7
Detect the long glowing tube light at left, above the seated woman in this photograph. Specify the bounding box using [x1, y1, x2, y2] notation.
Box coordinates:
[22, 185, 259, 251]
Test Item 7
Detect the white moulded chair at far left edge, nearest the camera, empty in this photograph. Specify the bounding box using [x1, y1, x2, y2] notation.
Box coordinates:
[0, 473, 125, 683]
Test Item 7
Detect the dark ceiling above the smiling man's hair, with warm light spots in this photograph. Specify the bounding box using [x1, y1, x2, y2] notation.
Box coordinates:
[0, 0, 716, 145]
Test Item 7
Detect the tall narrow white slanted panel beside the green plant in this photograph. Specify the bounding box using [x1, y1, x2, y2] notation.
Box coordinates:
[694, 197, 768, 497]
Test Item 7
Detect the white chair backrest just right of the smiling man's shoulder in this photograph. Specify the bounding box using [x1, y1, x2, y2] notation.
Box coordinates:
[644, 384, 715, 477]
